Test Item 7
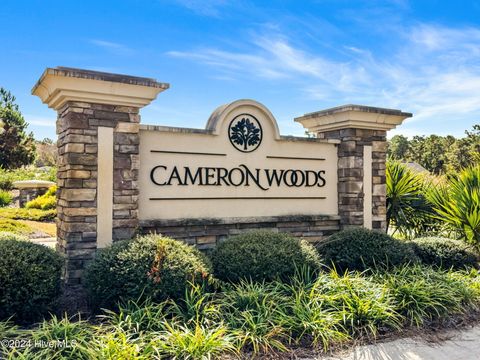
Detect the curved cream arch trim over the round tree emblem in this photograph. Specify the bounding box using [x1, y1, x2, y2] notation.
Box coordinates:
[205, 99, 280, 140]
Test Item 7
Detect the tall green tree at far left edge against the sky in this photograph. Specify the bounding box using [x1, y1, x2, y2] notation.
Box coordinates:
[0, 88, 35, 169]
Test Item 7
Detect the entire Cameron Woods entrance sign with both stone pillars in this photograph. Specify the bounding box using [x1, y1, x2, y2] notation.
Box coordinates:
[32, 67, 411, 285]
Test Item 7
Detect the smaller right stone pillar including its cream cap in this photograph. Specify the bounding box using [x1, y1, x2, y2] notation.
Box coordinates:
[295, 105, 412, 231]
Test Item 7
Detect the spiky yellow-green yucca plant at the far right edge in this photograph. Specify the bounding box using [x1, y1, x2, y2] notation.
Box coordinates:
[428, 165, 480, 249]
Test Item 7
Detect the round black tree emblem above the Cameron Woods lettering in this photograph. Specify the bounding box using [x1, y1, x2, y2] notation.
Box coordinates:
[228, 114, 263, 152]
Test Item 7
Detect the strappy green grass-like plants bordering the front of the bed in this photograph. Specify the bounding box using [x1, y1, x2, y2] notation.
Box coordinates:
[0, 265, 480, 359]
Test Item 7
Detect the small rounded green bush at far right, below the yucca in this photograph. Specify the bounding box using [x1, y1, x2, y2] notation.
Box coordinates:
[412, 237, 479, 269]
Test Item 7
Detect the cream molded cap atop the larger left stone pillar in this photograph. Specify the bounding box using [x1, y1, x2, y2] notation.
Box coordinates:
[32, 67, 170, 110]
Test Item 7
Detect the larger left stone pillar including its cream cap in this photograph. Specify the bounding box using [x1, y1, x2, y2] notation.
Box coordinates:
[32, 68, 168, 285]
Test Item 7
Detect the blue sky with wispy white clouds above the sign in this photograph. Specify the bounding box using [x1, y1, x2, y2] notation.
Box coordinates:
[0, 0, 480, 139]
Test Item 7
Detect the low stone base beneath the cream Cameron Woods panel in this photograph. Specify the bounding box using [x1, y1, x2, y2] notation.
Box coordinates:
[140, 215, 340, 250]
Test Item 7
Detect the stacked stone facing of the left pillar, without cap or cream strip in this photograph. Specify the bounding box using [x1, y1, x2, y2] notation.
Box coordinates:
[57, 102, 140, 285]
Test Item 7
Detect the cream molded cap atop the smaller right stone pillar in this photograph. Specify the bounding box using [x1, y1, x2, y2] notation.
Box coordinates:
[295, 104, 412, 132]
